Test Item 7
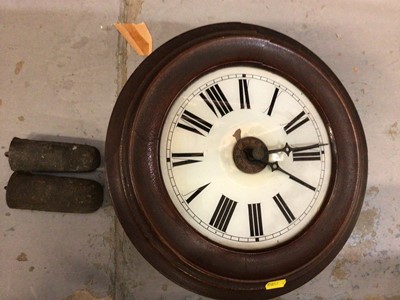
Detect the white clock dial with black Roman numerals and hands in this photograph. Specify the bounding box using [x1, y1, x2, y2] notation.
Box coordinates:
[160, 66, 332, 250]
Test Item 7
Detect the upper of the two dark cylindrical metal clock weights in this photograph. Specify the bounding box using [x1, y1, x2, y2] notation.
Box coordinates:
[6, 138, 100, 172]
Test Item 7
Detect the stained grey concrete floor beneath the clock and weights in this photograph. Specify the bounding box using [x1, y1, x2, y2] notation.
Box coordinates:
[0, 0, 400, 300]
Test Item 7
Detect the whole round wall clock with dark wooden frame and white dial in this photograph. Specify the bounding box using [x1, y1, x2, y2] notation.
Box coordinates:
[106, 23, 367, 299]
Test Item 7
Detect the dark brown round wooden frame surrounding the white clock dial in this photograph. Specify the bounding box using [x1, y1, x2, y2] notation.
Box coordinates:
[106, 23, 367, 299]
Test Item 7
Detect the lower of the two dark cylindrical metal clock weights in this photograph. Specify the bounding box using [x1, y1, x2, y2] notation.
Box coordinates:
[6, 172, 103, 213]
